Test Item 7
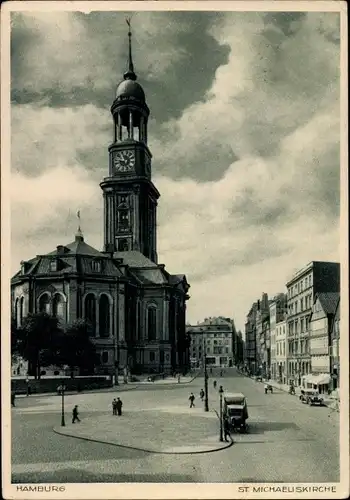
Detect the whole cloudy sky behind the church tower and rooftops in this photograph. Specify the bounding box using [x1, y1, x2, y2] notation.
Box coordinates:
[11, 5, 340, 329]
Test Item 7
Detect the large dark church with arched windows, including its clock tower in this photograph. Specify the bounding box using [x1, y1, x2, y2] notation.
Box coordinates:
[11, 26, 189, 375]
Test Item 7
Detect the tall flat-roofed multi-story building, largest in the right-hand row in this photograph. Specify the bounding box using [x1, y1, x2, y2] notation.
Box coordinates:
[286, 261, 340, 385]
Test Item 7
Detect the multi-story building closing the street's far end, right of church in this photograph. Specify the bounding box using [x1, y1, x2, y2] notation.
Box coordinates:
[186, 317, 234, 367]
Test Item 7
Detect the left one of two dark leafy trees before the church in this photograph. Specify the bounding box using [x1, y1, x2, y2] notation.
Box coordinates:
[15, 312, 61, 378]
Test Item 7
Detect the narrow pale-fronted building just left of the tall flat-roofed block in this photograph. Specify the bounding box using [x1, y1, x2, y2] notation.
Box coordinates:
[269, 293, 287, 380]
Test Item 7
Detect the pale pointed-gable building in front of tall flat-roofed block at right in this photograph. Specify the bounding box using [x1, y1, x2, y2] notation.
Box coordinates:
[304, 292, 339, 392]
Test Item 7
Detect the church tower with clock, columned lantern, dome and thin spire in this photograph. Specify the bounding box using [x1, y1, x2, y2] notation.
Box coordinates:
[100, 20, 160, 264]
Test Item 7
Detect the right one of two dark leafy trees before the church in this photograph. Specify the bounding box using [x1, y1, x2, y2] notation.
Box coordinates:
[56, 319, 97, 374]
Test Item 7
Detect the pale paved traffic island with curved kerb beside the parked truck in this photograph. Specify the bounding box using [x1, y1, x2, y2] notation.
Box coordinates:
[53, 405, 232, 454]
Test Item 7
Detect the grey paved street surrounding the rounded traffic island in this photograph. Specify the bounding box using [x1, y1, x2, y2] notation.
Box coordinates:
[12, 368, 339, 483]
